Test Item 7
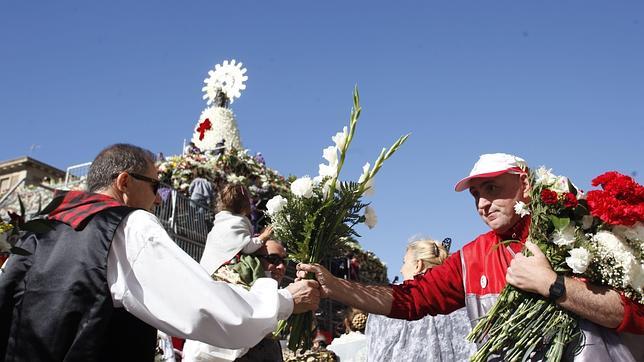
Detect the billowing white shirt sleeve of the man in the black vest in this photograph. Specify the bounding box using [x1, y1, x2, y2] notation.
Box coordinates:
[107, 210, 293, 348]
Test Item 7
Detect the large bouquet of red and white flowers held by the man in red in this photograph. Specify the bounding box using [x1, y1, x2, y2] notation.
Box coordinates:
[468, 167, 644, 361]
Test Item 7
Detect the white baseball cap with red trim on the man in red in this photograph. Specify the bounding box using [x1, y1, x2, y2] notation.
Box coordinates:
[454, 153, 528, 192]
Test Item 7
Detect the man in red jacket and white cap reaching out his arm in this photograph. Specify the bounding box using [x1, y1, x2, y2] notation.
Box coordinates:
[298, 153, 644, 361]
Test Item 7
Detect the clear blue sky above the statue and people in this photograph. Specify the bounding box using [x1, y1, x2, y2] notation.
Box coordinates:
[0, 0, 644, 277]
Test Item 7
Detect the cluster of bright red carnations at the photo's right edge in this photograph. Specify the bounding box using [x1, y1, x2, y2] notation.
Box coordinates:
[588, 171, 644, 226]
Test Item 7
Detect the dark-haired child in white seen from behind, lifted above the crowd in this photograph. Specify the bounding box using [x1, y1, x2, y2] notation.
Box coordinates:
[201, 184, 273, 274]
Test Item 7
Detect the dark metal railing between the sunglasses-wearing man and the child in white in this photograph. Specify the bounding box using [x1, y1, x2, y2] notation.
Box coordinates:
[154, 185, 215, 261]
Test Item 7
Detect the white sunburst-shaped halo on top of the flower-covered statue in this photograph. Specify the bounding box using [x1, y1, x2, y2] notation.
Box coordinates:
[201, 59, 248, 105]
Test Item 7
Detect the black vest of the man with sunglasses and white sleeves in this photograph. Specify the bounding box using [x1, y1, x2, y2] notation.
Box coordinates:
[0, 207, 156, 362]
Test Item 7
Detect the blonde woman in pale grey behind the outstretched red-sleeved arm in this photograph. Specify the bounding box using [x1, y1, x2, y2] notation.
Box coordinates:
[366, 239, 476, 361]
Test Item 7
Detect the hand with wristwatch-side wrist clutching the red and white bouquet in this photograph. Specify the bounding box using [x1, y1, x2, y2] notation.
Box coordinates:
[505, 241, 557, 297]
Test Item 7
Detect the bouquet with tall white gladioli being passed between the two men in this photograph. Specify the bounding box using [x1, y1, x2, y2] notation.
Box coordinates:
[266, 88, 409, 350]
